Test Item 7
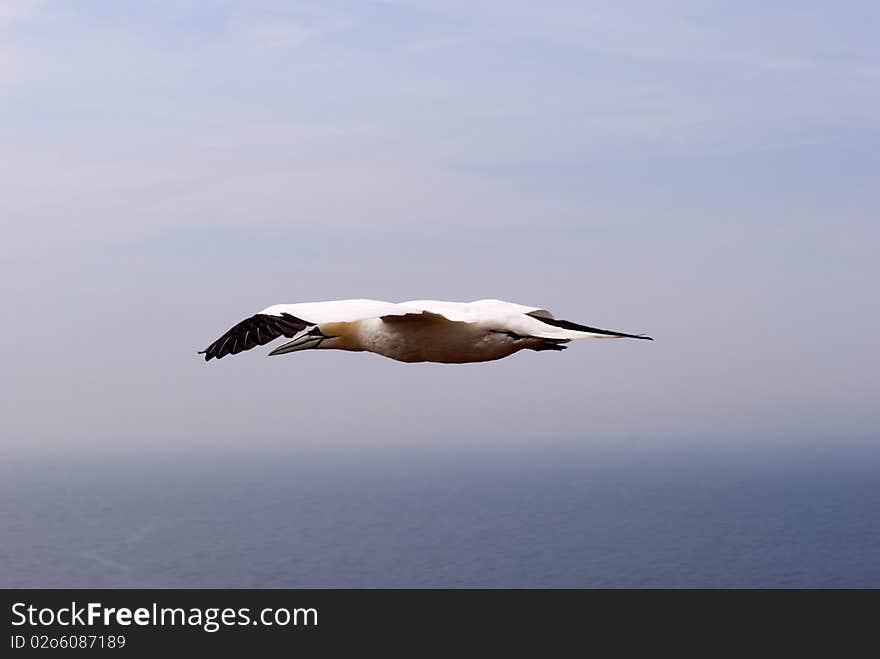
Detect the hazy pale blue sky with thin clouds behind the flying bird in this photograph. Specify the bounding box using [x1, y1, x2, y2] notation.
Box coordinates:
[0, 0, 880, 454]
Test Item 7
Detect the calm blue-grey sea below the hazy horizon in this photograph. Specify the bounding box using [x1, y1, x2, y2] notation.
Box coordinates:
[0, 441, 880, 587]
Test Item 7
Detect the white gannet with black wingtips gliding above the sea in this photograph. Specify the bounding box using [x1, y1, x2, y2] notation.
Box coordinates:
[199, 300, 653, 364]
